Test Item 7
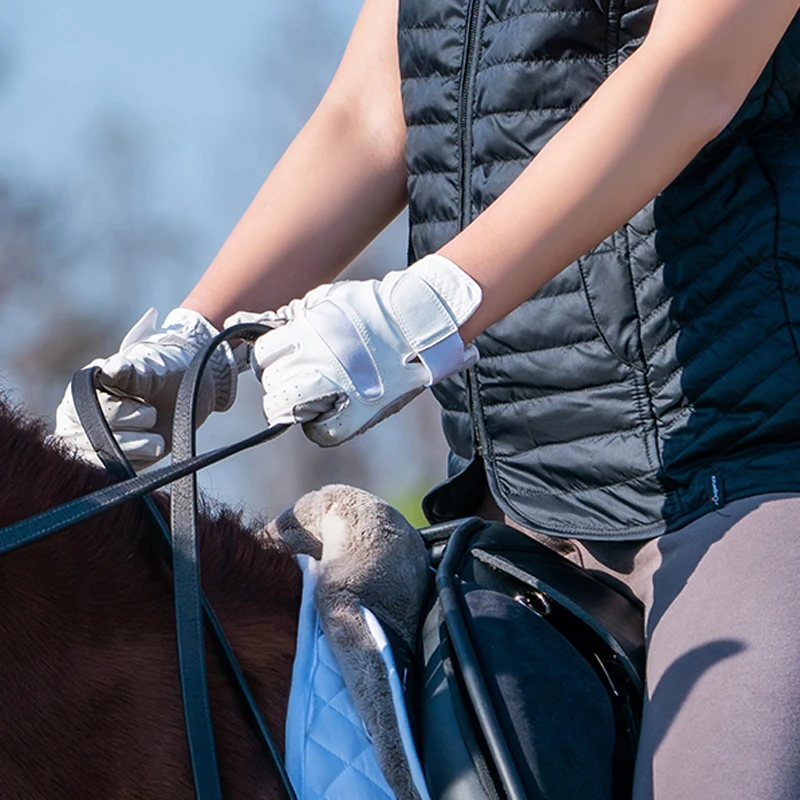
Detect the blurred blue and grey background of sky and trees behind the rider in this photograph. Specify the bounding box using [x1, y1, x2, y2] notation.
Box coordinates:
[0, 0, 446, 523]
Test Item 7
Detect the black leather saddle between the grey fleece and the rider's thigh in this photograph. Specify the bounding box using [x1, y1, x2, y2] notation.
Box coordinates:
[414, 518, 644, 800]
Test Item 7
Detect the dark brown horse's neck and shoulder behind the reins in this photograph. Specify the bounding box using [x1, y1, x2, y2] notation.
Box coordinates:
[0, 397, 301, 800]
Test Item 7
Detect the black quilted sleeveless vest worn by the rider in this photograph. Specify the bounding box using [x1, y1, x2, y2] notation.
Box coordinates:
[398, 0, 800, 539]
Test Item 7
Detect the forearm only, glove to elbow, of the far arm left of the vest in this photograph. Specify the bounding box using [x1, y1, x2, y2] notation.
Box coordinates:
[181, 104, 405, 326]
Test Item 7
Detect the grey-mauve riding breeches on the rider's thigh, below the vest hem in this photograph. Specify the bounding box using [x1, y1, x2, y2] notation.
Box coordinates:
[482, 494, 800, 800]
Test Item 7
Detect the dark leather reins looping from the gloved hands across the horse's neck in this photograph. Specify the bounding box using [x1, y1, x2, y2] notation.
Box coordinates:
[0, 324, 296, 800]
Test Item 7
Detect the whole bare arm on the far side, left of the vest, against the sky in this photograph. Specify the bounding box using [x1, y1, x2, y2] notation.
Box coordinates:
[181, 0, 406, 327]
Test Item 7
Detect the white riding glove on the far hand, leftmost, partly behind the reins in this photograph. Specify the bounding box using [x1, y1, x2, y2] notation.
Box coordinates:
[54, 308, 240, 469]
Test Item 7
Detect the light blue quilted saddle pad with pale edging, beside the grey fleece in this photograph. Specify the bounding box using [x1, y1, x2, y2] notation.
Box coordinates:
[286, 555, 429, 800]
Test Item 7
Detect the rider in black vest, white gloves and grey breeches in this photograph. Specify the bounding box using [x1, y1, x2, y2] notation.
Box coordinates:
[56, 0, 800, 800]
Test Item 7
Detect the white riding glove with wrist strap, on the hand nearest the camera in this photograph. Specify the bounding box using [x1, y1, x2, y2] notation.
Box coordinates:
[225, 255, 482, 446]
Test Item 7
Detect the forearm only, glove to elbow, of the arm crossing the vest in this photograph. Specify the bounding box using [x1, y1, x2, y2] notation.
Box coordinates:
[440, 43, 736, 341]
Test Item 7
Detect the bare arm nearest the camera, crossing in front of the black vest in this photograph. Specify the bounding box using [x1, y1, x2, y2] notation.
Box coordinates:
[450, 0, 800, 341]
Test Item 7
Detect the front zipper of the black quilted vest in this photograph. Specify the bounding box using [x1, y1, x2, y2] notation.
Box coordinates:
[458, 0, 483, 458]
